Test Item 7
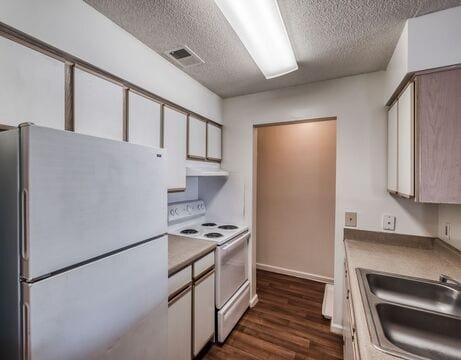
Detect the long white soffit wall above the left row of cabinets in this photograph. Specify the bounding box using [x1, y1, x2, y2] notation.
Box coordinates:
[0, 0, 222, 122]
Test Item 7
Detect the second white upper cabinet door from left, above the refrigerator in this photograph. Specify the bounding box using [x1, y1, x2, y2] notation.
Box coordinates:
[74, 69, 123, 140]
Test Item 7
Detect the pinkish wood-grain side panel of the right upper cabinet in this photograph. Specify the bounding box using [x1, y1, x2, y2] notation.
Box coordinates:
[416, 69, 461, 204]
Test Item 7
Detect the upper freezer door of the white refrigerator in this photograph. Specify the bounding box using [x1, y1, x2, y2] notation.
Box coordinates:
[20, 126, 167, 280]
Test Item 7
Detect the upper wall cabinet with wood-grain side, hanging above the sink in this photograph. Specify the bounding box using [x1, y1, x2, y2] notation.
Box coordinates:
[388, 69, 461, 204]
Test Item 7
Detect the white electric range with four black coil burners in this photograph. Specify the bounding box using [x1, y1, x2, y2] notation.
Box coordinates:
[168, 200, 250, 342]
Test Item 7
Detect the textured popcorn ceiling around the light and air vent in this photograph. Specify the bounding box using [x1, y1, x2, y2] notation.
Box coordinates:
[84, 0, 461, 98]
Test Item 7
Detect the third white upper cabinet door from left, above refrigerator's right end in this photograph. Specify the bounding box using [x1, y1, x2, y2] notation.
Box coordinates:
[128, 91, 161, 147]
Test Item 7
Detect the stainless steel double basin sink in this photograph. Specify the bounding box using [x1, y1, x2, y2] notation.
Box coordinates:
[356, 269, 461, 360]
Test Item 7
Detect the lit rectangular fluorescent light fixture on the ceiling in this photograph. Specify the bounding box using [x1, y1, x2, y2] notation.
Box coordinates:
[215, 0, 298, 79]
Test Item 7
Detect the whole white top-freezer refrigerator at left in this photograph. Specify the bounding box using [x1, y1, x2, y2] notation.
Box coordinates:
[0, 125, 168, 360]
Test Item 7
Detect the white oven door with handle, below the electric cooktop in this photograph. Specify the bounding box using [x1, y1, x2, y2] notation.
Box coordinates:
[216, 232, 250, 309]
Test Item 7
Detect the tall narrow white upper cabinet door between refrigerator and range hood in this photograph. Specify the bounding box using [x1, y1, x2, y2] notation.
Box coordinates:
[163, 106, 187, 191]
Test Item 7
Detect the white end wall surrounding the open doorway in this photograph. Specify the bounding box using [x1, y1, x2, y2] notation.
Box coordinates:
[219, 72, 438, 332]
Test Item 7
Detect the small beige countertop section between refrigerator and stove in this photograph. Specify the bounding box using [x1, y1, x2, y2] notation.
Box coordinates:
[168, 235, 216, 276]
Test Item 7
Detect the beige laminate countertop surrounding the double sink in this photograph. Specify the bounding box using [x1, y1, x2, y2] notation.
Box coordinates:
[345, 238, 461, 360]
